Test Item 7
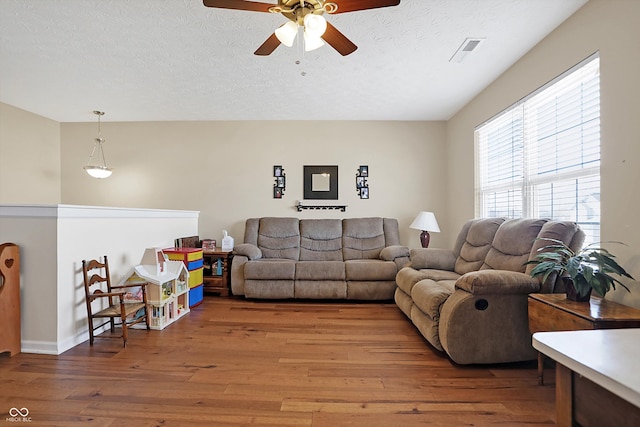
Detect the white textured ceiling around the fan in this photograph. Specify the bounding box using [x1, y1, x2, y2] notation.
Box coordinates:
[0, 0, 587, 122]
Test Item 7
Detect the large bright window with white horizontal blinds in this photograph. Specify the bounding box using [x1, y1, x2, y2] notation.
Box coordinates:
[475, 54, 600, 243]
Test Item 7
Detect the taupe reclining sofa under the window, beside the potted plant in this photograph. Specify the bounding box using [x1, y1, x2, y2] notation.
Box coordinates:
[394, 218, 585, 364]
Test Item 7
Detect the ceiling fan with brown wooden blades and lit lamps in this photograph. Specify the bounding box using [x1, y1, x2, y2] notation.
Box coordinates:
[203, 0, 400, 56]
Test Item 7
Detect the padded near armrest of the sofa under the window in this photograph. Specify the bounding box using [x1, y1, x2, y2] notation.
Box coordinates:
[456, 270, 540, 295]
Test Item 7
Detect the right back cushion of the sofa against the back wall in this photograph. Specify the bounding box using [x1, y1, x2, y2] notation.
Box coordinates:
[342, 218, 387, 261]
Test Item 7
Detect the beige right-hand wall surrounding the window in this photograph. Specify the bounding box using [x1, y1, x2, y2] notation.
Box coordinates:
[447, 0, 640, 307]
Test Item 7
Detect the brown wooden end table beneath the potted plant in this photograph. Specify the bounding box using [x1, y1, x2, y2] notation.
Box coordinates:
[529, 294, 640, 385]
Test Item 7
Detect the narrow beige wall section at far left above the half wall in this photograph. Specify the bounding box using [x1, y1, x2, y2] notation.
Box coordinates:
[0, 102, 60, 203]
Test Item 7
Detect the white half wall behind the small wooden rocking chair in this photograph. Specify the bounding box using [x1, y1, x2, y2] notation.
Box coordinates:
[0, 205, 199, 354]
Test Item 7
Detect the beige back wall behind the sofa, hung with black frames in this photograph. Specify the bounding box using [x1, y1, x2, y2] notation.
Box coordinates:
[61, 121, 446, 247]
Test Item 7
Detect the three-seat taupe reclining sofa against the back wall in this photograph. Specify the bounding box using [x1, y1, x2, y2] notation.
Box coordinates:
[231, 217, 409, 300]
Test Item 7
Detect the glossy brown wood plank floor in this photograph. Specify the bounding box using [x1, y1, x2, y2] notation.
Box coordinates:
[0, 296, 555, 427]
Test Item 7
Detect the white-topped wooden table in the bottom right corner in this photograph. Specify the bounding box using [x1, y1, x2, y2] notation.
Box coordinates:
[533, 329, 640, 427]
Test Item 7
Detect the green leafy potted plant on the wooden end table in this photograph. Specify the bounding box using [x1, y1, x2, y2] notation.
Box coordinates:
[526, 238, 635, 301]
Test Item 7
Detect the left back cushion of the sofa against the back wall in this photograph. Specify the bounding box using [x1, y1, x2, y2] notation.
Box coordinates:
[252, 217, 300, 261]
